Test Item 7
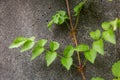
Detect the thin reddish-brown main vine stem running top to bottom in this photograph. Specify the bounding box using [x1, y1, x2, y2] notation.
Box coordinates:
[66, 0, 86, 80]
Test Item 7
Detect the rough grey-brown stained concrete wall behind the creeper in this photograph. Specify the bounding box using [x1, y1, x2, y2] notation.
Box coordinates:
[0, 0, 120, 80]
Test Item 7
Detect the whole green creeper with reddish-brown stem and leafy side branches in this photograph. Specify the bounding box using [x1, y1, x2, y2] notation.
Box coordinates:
[9, 0, 120, 80]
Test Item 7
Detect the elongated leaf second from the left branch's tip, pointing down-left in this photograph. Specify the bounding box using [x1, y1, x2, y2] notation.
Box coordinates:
[20, 40, 35, 52]
